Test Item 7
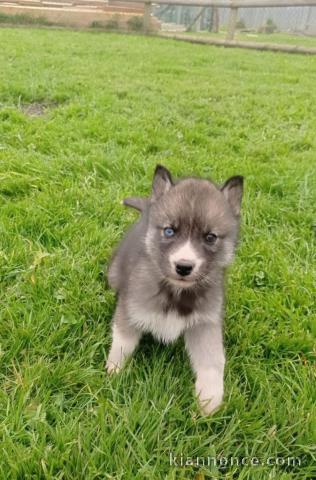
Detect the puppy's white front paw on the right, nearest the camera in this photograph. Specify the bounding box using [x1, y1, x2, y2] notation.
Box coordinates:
[195, 376, 224, 415]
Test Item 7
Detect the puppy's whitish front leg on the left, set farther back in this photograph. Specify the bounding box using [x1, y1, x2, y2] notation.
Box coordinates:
[106, 304, 141, 374]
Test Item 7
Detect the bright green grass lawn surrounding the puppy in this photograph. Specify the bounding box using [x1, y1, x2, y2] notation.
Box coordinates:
[0, 29, 316, 480]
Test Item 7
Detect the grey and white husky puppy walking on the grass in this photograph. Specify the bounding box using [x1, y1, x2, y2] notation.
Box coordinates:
[106, 165, 243, 414]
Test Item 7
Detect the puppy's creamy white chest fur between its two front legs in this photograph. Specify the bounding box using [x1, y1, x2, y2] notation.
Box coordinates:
[128, 305, 196, 343]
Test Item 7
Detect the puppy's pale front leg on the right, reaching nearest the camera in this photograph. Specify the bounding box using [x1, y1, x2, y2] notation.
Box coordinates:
[185, 322, 225, 415]
